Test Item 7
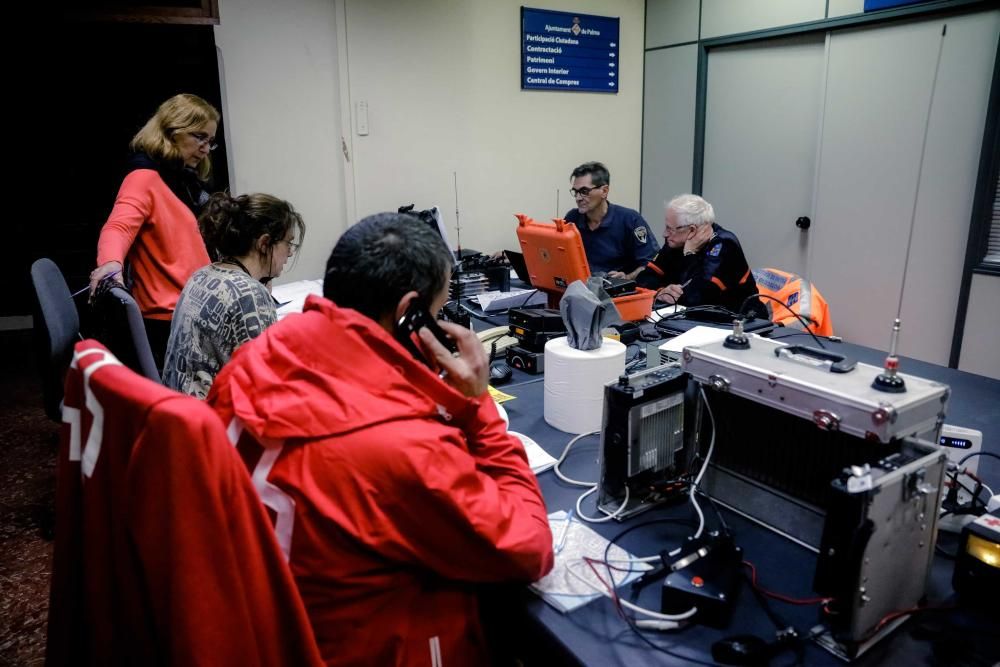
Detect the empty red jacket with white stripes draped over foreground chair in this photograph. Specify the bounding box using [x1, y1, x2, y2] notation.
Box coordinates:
[46, 340, 321, 667]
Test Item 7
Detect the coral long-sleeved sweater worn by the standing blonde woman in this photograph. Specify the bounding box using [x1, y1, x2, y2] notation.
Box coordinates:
[97, 169, 211, 320]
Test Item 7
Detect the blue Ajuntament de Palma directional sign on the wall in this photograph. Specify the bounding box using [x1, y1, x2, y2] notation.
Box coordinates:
[521, 7, 621, 93]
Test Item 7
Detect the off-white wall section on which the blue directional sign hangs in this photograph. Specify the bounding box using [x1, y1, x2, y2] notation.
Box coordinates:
[337, 0, 644, 251]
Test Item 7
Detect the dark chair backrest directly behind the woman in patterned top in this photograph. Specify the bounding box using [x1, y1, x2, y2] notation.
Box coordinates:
[94, 286, 161, 382]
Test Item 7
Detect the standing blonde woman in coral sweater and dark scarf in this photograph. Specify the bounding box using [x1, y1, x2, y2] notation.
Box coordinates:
[90, 94, 219, 368]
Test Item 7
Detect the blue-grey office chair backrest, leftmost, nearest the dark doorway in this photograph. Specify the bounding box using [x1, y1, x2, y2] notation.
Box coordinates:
[31, 257, 80, 421]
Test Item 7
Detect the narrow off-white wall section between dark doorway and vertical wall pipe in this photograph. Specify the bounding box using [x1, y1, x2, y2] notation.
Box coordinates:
[215, 0, 347, 282]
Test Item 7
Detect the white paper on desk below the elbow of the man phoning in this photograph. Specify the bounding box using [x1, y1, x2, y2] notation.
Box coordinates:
[529, 511, 652, 614]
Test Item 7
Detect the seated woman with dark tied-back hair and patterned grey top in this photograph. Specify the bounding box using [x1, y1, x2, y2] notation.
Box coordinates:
[163, 192, 305, 398]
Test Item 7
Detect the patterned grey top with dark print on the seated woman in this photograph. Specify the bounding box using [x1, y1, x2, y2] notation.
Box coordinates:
[163, 263, 278, 398]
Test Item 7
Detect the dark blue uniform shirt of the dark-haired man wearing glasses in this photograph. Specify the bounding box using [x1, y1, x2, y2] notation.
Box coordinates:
[566, 202, 660, 273]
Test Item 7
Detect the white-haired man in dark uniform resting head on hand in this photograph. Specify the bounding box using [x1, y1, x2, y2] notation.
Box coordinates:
[636, 194, 767, 318]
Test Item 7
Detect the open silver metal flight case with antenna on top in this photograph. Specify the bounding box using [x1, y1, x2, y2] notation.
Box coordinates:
[682, 337, 950, 660]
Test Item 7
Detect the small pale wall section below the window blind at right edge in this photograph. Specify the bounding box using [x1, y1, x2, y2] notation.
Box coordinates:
[958, 275, 1000, 380]
